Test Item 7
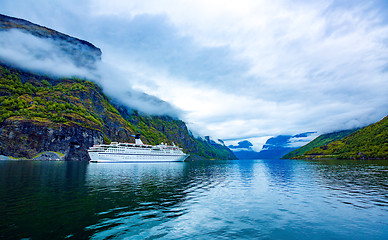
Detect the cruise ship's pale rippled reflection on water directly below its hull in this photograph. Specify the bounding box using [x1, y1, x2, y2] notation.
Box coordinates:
[85, 163, 186, 239]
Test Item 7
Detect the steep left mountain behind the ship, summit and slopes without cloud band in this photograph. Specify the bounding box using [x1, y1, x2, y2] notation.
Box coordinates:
[0, 15, 236, 160]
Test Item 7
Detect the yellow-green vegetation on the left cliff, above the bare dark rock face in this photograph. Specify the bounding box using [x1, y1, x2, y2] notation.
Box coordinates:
[0, 66, 140, 146]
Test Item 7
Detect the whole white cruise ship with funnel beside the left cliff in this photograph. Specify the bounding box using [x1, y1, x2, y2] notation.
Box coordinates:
[88, 134, 189, 162]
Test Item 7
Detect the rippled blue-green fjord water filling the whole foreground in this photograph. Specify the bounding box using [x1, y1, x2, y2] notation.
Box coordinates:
[0, 160, 388, 239]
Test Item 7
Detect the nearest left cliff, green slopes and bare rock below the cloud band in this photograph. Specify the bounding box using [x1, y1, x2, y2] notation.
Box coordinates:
[0, 65, 128, 160]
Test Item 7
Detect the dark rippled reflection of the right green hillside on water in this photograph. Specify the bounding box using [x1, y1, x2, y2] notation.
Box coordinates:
[311, 161, 388, 211]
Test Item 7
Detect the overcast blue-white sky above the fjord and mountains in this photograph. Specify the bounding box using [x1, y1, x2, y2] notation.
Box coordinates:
[0, 0, 388, 146]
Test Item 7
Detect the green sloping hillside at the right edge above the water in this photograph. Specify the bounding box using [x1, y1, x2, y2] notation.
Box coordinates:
[294, 116, 388, 159]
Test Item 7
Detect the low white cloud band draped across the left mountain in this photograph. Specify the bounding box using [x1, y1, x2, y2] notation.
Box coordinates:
[0, 29, 180, 117]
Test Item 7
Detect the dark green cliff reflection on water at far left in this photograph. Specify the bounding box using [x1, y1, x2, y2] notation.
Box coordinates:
[0, 161, 88, 239]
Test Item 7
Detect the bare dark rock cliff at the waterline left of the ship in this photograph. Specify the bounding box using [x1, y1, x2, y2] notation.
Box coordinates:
[0, 117, 103, 160]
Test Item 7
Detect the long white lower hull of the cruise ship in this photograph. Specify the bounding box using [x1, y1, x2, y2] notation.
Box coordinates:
[89, 152, 189, 162]
